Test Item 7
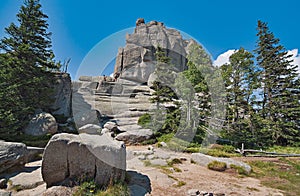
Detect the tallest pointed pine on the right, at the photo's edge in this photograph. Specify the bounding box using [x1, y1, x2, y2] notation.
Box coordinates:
[255, 21, 300, 145]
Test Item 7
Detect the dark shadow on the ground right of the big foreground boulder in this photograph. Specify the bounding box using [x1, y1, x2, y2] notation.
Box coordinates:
[127, 171, 152, 196]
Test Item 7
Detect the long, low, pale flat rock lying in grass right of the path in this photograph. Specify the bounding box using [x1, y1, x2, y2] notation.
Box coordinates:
[192, 153, 251, 173]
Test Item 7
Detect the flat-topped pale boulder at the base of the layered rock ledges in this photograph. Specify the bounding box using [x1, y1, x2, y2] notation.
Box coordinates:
[116, 129, 154, 144]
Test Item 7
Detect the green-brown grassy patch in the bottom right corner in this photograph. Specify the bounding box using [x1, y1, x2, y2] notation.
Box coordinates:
[249, 158, 300, 196]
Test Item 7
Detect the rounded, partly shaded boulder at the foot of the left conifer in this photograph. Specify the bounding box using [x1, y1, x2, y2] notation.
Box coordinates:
[24, 112, 58, 136]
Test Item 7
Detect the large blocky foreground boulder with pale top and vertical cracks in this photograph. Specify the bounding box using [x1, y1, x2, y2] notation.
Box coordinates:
[42, 133, 126, 187]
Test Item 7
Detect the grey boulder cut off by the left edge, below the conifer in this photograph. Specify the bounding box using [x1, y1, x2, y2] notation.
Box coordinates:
[0, 140, 27, 173]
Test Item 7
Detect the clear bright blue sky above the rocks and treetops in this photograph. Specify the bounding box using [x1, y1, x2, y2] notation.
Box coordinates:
[0, 0, 300, 79]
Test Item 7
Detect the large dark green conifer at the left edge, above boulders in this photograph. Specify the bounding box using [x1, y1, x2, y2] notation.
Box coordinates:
[0, 0, 57, 137]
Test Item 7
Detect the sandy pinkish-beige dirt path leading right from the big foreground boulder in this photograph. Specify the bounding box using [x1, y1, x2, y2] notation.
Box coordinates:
[127, 146, 283, 196]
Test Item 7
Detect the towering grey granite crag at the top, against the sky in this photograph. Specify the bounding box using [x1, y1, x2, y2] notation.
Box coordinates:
[114, 19, 194, 83]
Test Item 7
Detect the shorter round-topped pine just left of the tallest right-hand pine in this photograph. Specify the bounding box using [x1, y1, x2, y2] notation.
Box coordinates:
[221, 48, 257, 144]
